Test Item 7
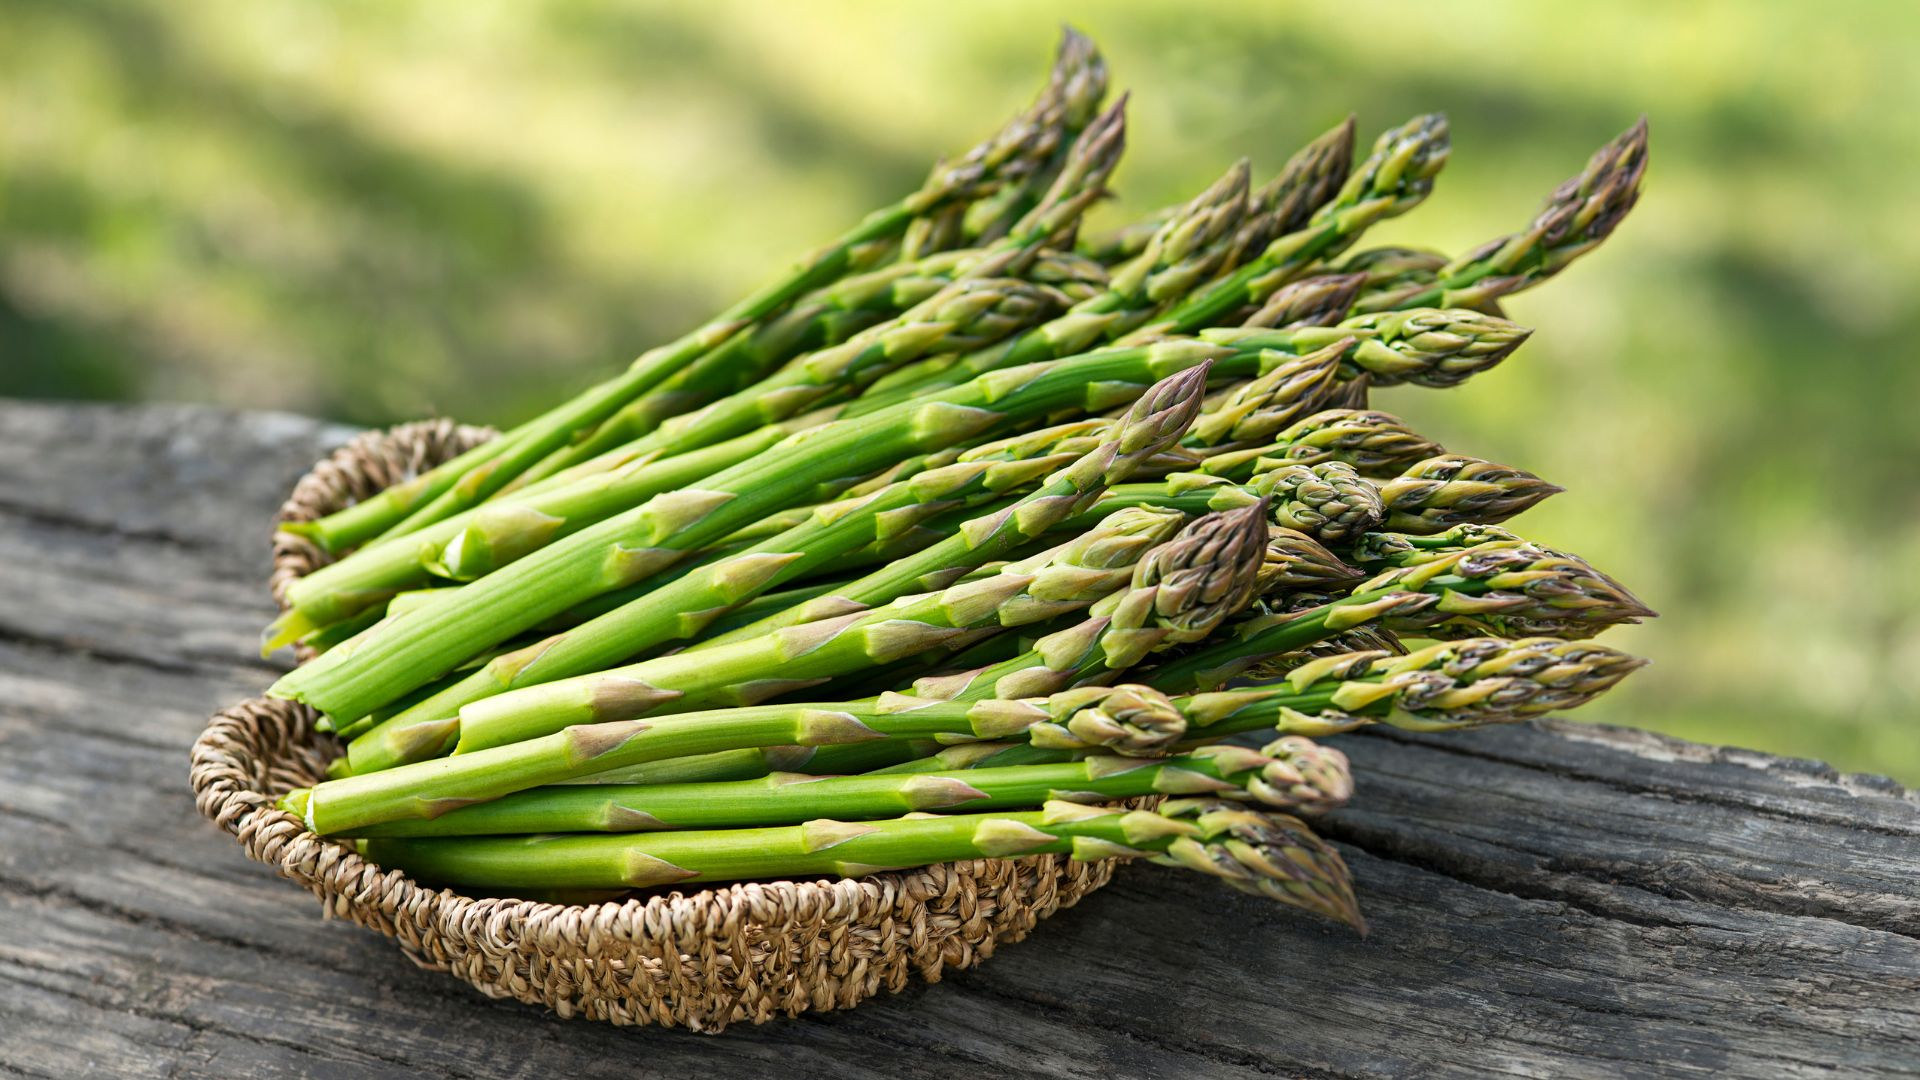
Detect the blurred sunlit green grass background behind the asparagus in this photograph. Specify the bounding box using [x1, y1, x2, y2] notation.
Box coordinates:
[0, 0, 1920, 780]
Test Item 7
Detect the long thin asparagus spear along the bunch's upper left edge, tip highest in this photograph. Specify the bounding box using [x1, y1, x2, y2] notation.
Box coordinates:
[282, 35, 1104, 552]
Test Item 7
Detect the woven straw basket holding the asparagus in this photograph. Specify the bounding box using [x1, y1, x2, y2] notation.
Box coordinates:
[192, 413, 1114, 1032]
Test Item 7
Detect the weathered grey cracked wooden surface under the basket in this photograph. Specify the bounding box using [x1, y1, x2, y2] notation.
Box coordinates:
[0, 402, 1920, 1080]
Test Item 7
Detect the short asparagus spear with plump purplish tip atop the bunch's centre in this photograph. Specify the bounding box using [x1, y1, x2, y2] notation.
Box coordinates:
[914, 500, 1282, 701]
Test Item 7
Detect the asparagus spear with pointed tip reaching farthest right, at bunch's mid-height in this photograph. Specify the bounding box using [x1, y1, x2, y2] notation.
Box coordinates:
[1150, 540, 1653, 692]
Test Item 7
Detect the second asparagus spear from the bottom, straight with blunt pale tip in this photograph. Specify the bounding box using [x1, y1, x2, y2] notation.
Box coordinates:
[337, 736, 1354, 836]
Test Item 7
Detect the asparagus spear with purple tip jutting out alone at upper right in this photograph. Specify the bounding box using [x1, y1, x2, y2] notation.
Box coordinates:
[1361, 117, 1647, 311]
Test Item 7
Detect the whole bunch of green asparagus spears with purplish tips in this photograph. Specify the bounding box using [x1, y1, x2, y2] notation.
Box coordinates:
[267, 31, 1651, 926]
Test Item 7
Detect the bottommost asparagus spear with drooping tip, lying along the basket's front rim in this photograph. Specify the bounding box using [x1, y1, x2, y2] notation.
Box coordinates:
[349, 799, 1365, 932]
